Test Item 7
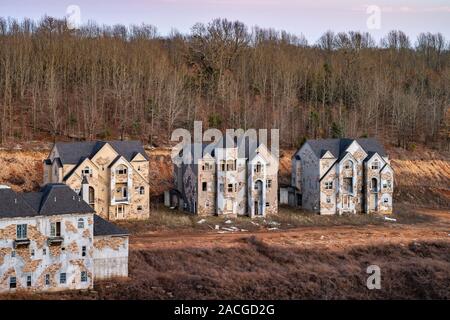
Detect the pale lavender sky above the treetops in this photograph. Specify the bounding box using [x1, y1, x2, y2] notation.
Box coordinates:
[0, 0, 450, 43]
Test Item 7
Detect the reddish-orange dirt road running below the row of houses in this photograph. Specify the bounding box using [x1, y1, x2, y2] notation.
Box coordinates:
[130, 209, 450, 250]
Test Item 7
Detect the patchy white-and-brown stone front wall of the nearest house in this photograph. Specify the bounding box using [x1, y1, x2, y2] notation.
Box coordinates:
[0, 214, 94, 292]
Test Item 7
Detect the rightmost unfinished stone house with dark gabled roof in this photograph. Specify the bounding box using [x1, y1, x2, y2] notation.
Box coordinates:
[289, 138, 394, 214]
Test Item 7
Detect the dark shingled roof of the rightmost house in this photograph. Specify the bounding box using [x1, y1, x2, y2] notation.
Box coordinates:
[306, 138, 386, 159]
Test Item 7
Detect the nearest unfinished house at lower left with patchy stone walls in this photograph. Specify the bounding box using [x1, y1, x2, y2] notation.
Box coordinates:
[0, 184, 128, 292]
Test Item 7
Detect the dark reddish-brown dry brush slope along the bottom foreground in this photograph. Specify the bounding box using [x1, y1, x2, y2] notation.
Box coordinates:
[5, 237, 450, 299]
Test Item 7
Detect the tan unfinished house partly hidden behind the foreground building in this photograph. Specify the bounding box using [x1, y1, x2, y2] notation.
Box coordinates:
[44, 141, 150, 220]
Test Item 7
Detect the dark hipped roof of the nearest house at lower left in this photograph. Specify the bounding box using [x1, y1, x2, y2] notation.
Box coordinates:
[0, 183, 94, 218]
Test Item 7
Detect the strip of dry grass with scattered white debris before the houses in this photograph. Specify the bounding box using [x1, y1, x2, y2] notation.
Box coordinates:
[116, 205, 433, 235]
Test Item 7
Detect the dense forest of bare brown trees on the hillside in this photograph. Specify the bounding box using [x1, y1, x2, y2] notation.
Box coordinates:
[0, 17, 450, 149]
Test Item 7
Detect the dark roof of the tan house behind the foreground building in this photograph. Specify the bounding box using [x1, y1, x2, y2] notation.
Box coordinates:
[51, 140, 149, 164]
